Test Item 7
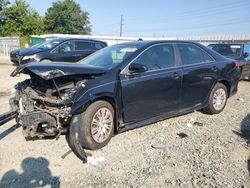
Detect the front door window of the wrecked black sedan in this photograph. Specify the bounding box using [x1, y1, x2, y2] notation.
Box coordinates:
[134, 44, 175, 71]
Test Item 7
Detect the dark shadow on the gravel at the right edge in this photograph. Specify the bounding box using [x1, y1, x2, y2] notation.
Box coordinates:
[233, 114, 250, 175]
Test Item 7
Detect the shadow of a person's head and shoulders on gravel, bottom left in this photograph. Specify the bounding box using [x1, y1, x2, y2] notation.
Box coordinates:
[0, 157, 60, 188]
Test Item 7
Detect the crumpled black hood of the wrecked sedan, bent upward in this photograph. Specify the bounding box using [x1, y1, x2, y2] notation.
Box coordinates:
[11, 63, 107, 80]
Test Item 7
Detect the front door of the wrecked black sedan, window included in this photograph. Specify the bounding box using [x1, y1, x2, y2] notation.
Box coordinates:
[120, 44, 181, 122]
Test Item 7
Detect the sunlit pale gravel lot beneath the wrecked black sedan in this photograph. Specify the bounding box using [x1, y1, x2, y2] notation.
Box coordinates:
[0, 61, 250, 188]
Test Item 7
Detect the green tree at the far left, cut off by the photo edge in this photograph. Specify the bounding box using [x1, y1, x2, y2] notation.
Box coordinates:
[0, 0, 44, 45]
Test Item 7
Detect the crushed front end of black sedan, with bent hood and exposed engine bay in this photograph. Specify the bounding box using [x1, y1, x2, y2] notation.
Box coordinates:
[10, 63, 105, 138]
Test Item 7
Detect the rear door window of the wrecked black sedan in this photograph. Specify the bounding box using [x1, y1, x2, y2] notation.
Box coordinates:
[177, 44, 214, 65]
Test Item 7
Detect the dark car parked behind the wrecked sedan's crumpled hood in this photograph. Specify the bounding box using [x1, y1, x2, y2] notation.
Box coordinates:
[10, 38, 107, 66]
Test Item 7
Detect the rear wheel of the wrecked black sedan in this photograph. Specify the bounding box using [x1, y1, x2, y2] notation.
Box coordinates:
[204, 83, 228, 114]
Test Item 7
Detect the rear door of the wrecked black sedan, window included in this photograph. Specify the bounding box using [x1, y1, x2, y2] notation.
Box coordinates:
[176, 43, 219, 110]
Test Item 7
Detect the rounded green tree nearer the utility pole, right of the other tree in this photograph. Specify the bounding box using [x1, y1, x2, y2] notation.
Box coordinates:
[44, 0, 91, 34]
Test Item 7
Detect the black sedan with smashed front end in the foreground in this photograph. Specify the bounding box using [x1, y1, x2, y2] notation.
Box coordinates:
[10, 41, 240, 158]
